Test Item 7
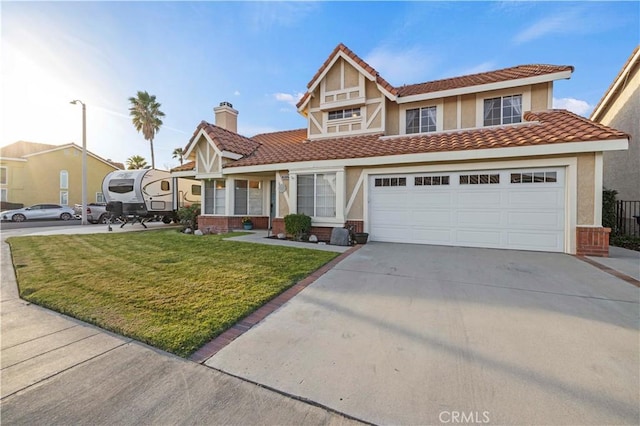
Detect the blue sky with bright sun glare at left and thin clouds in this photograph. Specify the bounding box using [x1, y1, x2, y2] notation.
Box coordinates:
[0, 1, 640, 169]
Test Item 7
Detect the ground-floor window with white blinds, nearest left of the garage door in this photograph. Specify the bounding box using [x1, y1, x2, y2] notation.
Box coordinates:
[297, 173, 336, 217]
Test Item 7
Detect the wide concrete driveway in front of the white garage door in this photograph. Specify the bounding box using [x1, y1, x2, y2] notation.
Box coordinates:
[206, 243, 640, 424]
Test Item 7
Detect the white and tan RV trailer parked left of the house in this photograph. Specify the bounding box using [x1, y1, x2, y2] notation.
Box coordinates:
[102, 169, 200, 217]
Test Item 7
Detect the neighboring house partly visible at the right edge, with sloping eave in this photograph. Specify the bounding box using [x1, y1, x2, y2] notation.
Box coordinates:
[591, 46, 640, 203]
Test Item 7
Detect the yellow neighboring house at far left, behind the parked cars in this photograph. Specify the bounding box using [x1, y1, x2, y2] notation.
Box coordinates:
[0, 141, 124, 206]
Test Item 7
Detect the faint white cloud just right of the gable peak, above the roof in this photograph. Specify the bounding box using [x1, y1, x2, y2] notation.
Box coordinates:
[363, 46, 439, 85]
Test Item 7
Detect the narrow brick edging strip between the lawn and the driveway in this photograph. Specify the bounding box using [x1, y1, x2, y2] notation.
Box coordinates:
[188, 245, 362, 364]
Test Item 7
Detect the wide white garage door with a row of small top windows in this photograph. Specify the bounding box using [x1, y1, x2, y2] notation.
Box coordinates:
[369, 168, 565, 252]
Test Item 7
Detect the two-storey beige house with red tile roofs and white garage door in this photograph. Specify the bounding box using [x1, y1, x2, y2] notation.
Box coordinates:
[176, 44, 628, 255]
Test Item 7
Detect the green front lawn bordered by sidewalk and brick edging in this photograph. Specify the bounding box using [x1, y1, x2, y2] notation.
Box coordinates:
[8, 230, 336, 357]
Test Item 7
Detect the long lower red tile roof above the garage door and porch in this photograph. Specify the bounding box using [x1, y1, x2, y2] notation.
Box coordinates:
[226, 110, 627, 167]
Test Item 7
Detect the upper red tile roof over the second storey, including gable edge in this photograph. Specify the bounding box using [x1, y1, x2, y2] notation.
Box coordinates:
[297, 43, 573, 108]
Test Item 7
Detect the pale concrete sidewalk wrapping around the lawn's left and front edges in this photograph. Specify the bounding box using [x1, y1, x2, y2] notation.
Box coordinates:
[0, 224, 357, 425]
